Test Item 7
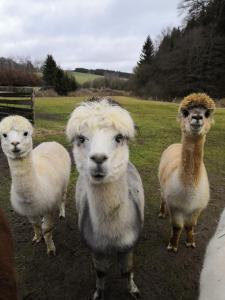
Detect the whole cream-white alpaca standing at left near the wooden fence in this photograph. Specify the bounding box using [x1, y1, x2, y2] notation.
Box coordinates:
[0, 116, 71, 254]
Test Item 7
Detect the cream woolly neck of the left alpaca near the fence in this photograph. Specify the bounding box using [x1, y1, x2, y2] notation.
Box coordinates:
[8, 152, 37, 200]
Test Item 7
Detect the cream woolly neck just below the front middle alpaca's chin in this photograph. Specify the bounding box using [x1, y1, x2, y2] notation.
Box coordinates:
[88, 173, 128, 219]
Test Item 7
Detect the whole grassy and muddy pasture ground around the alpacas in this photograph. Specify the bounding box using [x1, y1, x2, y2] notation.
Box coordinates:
[0, 97, 225, 300]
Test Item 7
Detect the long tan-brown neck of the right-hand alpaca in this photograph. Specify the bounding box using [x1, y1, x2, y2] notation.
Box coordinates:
[181, 135, 205, 184]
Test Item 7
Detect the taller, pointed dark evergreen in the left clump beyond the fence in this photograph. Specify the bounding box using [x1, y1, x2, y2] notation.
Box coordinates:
[42, 55, 57, 87]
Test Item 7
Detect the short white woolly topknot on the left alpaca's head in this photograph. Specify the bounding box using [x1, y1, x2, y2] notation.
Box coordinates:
[0, 115, 33, 134]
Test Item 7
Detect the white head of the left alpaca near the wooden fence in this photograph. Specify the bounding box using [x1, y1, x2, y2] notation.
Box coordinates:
[0, 116, 33, 159]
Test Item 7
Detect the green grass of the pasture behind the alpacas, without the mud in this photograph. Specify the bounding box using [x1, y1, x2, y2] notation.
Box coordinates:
[31, 97, 225, 216]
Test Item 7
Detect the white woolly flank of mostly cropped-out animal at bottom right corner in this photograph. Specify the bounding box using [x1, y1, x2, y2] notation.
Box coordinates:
[199, 210, 225, 300]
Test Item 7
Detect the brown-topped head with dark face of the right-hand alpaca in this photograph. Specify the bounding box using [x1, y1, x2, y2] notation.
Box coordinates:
[179, 93, 215, 136]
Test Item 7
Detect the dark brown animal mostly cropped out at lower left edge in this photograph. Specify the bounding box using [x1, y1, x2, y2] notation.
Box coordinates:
[0, 209, 18, 300]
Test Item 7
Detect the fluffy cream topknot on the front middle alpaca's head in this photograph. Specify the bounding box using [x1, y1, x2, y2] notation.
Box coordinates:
[66, 98, 135, 141]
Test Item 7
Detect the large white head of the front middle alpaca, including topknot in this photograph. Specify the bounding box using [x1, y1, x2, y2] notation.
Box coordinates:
[66, 98, 135, 184]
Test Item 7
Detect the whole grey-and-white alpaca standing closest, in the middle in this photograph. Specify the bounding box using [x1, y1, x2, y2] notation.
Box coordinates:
[67, 98, 144, 299]
